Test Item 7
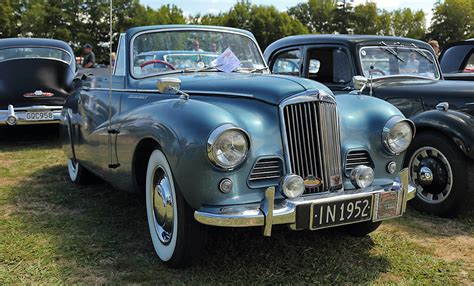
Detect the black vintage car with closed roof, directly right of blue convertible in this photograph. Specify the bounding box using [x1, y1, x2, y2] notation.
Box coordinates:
[265, 35, 474, 216]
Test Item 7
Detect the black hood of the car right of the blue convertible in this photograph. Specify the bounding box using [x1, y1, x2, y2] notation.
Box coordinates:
[372, 78, 474, 98]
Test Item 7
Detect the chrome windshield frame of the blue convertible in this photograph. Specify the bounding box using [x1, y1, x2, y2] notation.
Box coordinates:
[128, 28, 269, 79]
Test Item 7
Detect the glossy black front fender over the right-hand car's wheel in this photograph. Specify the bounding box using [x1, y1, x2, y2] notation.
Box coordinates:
[410, 110, 474, 159]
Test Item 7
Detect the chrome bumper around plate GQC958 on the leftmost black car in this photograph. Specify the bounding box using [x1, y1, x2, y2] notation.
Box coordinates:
[0, 105, 63, 125]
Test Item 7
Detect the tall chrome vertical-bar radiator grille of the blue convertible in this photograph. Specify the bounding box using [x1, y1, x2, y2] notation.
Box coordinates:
[283, 101, 342, 194]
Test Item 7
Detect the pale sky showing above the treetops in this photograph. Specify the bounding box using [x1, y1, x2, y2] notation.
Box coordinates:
[140, 0, 436, 20]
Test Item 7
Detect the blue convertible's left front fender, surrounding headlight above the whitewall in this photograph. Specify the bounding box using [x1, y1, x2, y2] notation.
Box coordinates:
[117, 98, 282, 208]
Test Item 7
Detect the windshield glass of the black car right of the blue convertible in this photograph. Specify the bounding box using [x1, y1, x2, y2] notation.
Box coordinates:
[360, 46, 440, 79]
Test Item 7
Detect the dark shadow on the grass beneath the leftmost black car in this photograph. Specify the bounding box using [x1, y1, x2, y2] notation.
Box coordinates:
[0, 124, 60, 151]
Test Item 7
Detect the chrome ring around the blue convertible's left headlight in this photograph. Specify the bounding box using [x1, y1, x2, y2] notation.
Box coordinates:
[207, 124, 250, 171]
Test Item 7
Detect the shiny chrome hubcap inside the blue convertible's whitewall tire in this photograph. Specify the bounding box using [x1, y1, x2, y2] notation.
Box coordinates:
[152, 167, 174, 244]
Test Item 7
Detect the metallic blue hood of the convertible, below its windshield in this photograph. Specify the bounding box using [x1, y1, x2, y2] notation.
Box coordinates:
[131, 72, 332, 105]
